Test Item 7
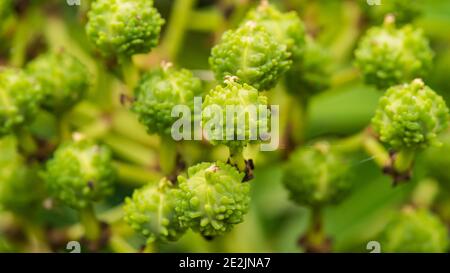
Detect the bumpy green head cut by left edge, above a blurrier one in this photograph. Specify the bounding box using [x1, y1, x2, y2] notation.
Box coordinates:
[0, 68, 42, 137]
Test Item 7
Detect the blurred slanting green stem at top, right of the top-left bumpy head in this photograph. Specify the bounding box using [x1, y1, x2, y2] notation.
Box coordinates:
[162, 0, 197, 61]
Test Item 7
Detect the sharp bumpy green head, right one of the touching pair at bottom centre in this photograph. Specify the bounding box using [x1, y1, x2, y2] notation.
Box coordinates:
[177, 162, 250, 236]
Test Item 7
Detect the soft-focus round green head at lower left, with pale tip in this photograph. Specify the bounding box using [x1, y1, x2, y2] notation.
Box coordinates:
[42, 140, 116, 209]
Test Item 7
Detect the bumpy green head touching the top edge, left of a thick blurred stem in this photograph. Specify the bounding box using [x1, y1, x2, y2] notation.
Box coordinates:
[86, 0, 164, 57]
